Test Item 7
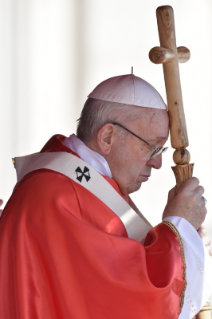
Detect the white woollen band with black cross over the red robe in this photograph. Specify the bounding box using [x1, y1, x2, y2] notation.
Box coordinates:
[14, 152, 152, 243]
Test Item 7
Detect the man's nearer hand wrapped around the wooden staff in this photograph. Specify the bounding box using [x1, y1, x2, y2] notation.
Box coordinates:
[163, 177, 207, 230]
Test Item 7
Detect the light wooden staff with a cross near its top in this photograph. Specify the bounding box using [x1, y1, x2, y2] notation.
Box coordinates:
[149, 6, 212, 319]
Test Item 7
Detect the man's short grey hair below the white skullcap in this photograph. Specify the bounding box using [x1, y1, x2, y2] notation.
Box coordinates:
[77, 98, 148, 142]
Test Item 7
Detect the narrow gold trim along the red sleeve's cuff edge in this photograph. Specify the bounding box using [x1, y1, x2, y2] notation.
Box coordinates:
[162, 220, 187, 314]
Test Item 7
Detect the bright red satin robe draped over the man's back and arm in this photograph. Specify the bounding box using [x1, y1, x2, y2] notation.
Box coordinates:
[0, 135, 185, 319]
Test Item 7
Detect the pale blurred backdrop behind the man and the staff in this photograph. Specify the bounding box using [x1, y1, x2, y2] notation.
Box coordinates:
[0, 0, 212, 235]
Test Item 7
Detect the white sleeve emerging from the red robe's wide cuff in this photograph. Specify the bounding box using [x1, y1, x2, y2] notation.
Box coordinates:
[165, 216, 212, 319]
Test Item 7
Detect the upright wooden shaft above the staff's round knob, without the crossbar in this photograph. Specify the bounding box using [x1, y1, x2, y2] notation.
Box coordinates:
[156, 6, 189, 149]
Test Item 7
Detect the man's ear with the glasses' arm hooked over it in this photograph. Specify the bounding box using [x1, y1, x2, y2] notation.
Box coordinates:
[97, 123, 117, 156]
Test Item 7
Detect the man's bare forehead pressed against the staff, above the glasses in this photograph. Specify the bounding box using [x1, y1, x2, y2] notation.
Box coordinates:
[132, 108, 169, 139]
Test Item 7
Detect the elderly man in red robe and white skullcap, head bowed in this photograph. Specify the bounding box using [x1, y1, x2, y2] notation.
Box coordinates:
[0, 74, 211, 319]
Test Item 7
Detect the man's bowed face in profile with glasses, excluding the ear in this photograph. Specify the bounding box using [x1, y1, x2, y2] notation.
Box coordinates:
[106, 108, 169, 195]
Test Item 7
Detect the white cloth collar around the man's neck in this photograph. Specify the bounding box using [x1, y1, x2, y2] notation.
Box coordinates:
[62, 134, 112, 178]
